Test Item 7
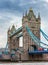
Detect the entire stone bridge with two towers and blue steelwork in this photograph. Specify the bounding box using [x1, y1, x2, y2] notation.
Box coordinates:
[0, 8, 48, 61]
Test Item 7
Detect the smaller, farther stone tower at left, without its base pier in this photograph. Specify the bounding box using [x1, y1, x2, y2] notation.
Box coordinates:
[8, 25, 19, 51]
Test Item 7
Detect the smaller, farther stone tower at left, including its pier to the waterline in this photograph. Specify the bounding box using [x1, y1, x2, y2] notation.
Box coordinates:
[7, 25, 19, 61]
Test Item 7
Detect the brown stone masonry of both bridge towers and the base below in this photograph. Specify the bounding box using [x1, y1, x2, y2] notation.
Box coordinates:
[8, 8, 48, 61]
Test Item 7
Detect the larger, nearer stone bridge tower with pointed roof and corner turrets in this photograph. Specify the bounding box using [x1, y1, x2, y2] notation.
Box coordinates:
[22, 8, 40, 60]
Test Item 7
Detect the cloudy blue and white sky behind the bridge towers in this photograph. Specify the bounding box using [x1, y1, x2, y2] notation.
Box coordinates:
[0, 0, 48, 48]
